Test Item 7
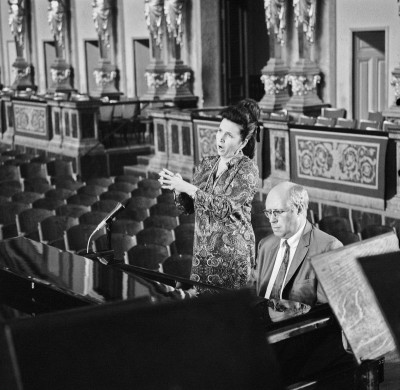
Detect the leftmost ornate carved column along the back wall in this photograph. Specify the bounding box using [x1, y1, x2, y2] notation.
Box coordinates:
[8, 0, 36, 90]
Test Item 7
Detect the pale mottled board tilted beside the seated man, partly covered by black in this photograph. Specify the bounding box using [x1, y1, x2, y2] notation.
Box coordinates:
[311, 232, 399, 363]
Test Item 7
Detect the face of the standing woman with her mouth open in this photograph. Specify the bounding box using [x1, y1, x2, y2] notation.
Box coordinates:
[216, 118, 244, 158]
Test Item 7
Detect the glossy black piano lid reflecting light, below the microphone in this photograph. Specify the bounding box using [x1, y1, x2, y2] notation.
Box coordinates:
[0, 237, 191, 304]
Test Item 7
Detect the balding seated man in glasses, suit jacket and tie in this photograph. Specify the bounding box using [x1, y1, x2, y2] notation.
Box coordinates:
[253, 182, 343, 306]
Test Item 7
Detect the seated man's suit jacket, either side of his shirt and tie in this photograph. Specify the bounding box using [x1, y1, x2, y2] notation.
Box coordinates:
[253, 221, 343, 306]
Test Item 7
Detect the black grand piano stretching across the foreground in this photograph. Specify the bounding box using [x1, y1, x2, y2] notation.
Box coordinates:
[0, 237, 382, 390]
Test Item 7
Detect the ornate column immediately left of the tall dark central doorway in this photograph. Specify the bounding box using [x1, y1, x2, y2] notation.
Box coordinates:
[164, 0, 196, 104]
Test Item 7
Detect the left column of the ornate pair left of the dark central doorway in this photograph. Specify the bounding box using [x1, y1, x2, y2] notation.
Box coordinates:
[142, 0, 167, 99]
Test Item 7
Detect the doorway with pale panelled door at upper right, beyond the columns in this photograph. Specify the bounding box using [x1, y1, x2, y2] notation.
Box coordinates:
[353, 30, 387, 120]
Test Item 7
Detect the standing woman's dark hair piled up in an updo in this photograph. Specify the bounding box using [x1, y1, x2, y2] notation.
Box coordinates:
[221, 99, 261, 158]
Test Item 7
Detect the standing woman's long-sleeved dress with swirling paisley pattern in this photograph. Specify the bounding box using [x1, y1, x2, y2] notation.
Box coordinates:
[177, 155, 258, 292]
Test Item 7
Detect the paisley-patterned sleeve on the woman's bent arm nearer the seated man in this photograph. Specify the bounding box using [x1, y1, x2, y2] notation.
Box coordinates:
[194, 160, 258, 220]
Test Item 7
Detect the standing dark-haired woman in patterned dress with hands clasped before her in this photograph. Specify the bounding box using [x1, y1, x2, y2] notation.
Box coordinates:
[159, 99, 260, 292]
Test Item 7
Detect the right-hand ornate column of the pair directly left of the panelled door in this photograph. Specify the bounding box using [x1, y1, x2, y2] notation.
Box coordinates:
[287, 0, 324, 114]
